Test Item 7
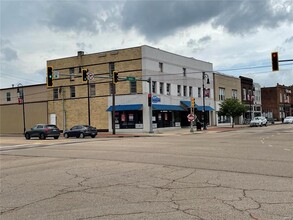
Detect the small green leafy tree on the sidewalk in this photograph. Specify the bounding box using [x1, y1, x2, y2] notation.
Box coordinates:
[218, 98, 247, 128]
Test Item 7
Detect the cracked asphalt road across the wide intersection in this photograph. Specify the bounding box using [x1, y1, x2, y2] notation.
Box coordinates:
[0, 125, 293, 220]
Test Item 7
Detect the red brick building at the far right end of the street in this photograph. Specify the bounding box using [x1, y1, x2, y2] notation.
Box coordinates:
[261, 84, 293, 120]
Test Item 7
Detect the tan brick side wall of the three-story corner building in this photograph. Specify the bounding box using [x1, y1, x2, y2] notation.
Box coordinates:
[47, 47, 142, 129]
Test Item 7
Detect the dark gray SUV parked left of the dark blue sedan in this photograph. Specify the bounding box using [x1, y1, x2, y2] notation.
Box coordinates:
[24, 124, 61, 140]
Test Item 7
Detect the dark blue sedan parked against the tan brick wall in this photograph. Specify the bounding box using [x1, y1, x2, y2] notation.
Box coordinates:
[64, 125, 98, 138]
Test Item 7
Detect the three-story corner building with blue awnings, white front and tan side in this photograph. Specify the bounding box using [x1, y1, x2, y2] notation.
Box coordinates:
[47, 46, 215, 132]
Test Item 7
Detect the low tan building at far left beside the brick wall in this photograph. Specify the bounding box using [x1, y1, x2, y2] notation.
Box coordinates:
[0, 84, 48, 134]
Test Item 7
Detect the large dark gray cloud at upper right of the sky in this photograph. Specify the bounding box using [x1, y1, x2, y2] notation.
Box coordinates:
[122, 0, 293, 41]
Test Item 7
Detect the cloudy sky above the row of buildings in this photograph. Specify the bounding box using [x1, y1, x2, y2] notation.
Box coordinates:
[0, 0, 293, 88]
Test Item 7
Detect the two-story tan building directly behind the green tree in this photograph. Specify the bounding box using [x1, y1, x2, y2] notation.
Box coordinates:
[214, 72, 242, 125]
